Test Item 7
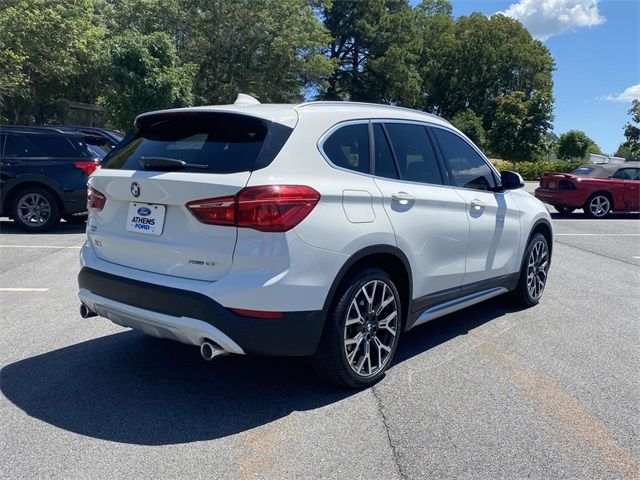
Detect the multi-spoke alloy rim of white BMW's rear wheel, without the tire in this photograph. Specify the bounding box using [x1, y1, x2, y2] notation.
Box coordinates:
[344, 280, 399, 377]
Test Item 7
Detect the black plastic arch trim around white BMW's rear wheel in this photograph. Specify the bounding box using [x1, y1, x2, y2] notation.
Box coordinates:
[323, 245, 413, 328]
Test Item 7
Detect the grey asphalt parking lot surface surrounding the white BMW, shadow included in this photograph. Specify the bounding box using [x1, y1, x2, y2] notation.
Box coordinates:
[0, 193, 640, 479]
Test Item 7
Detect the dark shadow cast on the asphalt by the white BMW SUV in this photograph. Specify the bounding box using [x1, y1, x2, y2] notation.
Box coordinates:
[0, 301, 510, 445]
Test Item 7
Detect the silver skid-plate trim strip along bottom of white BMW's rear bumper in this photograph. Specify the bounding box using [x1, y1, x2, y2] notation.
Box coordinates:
[78, 288, 244, 354]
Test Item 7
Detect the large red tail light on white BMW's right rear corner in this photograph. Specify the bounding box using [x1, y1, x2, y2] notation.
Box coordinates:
[186, 185, 320, 232]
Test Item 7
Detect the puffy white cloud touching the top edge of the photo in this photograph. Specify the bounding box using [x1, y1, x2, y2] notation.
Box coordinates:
[499, 0, 605, 40]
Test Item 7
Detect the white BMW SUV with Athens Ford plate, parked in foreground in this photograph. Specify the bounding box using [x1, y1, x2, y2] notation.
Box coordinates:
[78, 95, 553, 387]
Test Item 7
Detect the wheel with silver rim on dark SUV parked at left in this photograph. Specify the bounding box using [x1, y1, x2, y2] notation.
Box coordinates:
[11, 186, 60, 233]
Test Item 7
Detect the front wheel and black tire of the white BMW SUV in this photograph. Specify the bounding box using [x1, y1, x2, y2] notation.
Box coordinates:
[513, 233, 551, 307]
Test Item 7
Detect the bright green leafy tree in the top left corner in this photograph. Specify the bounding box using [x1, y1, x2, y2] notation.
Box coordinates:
[0, 0, 105, 123]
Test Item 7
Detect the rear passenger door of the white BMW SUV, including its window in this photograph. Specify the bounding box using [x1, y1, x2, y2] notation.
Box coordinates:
[371, 121, 469, 300]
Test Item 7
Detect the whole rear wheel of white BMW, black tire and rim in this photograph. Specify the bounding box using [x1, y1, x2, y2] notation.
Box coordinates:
[311, 268, 403, 388]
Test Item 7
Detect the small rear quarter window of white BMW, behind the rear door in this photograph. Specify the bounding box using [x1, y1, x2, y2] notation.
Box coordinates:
[322, 123, 370, 173]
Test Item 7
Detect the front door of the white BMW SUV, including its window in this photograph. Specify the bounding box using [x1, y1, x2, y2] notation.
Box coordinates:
[431, 126, 521, 285]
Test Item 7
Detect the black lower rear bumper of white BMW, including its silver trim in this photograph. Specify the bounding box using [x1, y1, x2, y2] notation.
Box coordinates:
[78, 267, 325, 356]
